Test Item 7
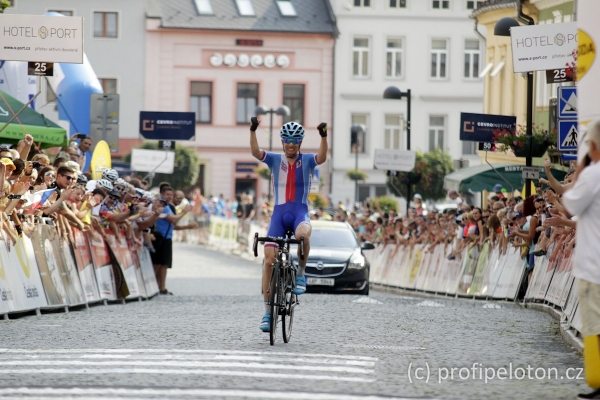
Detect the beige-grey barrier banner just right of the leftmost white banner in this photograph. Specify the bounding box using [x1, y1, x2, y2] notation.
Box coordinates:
[31, 225, 68, 306]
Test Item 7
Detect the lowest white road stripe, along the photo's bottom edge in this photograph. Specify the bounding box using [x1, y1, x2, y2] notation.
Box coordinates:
[0, 387, 426, 400]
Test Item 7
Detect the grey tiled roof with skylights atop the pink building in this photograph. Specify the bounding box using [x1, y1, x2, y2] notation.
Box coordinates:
[146, 0, 338, 36]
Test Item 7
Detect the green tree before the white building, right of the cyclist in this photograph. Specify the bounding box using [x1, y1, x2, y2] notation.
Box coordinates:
[387, 149, 453, 200]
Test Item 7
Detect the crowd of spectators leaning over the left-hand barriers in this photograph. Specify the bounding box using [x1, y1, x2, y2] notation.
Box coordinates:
[0, 135, 204, 294]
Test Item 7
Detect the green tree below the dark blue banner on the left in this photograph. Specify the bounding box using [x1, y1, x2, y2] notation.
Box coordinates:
[125, 142, 200, 189]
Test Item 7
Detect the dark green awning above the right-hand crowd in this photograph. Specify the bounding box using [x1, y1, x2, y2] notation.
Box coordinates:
[444, 164, 565, 193]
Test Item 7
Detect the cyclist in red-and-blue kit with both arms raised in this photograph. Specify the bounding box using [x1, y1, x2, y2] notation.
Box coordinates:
[250, 117, 327, 332]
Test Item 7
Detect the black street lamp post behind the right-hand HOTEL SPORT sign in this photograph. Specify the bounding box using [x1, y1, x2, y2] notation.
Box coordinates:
[494, 0, 535, 198]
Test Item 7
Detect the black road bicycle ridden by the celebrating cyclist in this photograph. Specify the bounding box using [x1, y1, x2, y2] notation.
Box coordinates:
[254, 231, 304, 346]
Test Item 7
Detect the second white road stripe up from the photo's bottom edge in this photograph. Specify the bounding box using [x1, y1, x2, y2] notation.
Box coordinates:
[0, 363, 376, 383]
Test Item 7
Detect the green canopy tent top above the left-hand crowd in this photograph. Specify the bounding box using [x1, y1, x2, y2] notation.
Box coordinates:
[0, 91, 68, 147]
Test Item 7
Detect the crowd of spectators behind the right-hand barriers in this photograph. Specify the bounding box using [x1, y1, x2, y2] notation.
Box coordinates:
[298, 160, 576, 296]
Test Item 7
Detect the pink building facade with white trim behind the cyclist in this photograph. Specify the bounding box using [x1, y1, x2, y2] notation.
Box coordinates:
[144, 1, 335, 200]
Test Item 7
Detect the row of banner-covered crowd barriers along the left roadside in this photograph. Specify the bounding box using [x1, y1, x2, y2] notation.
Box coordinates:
[0, 224, 158, 319]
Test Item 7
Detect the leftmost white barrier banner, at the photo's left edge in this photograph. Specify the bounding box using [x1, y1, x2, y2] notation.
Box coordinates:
[0, 235, 48, 311]
